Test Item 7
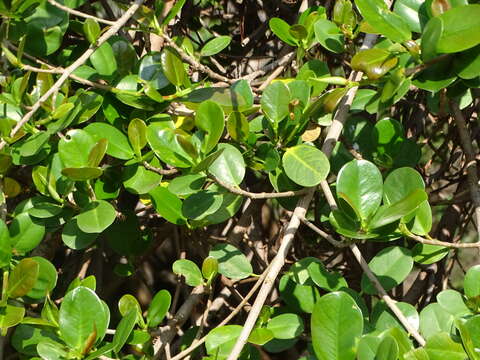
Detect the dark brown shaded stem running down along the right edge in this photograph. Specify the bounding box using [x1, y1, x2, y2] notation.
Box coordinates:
[450, 100, 480, 242]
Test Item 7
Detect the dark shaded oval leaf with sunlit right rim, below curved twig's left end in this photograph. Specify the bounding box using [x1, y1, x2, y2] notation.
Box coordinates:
[182, 190, 223, 220]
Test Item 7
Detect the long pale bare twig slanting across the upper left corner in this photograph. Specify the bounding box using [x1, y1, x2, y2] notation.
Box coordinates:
[0, 0, 144, 150]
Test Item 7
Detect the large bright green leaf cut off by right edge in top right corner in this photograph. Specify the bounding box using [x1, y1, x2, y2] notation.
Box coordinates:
[437, 4, 480, 53]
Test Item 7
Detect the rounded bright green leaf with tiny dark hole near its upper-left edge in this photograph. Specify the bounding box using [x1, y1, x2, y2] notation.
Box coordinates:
[58, 129, 95, 168]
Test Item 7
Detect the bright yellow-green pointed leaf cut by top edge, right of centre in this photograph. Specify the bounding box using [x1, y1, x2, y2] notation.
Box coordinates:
[355, 0, 412, 43]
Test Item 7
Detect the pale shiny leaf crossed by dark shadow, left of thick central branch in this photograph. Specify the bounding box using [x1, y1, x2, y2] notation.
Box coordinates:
[208, 243, 253, 280]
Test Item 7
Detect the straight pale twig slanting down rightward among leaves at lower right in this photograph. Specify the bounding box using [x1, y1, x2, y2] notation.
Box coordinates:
[350, 244, 425, 346]
